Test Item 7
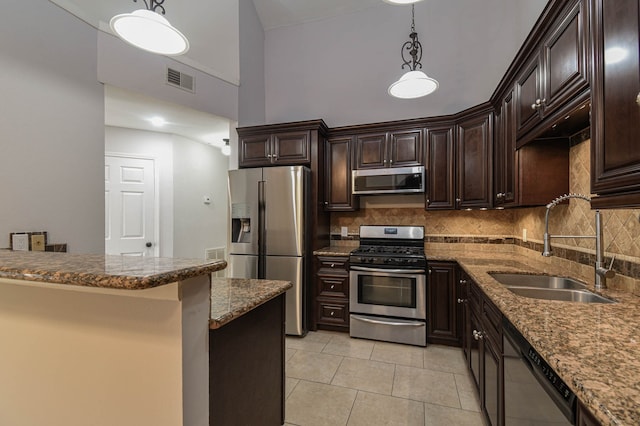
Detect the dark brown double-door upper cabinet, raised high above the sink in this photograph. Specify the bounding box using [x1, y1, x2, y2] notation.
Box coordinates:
[515, 0, 590, 146]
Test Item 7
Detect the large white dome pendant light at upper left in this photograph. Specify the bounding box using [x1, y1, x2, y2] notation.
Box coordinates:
[109, 0, 189, 56]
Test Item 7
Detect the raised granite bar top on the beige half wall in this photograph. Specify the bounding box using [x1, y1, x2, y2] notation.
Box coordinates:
[0, 251, 227, 290]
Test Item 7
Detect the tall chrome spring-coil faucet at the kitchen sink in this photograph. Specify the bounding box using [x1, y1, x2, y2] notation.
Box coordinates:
[542, 194, 616, 291]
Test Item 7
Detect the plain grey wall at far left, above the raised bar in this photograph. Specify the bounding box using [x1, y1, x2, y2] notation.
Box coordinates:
[0, 0, 104, 253]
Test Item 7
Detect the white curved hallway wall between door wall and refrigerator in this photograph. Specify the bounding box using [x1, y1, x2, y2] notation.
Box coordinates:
[173, 135, 228, 258]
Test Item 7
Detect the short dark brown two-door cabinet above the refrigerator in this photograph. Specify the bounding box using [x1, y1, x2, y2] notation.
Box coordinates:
[238, 130, 311, 167]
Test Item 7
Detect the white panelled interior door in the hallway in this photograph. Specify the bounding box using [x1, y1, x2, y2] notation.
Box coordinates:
[104, 155, 158, 256]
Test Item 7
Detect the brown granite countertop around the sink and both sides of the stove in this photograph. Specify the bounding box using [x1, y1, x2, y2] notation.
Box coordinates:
[314, 244, 640, 426]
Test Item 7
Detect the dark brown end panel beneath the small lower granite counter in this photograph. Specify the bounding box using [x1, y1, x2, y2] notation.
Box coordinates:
[209, 294, 285, 426]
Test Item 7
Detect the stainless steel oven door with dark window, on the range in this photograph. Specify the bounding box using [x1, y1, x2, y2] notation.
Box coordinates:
[349, 266, 427, 320]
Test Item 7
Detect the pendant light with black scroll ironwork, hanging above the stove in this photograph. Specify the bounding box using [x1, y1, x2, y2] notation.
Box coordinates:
[389, 4, 438, 99]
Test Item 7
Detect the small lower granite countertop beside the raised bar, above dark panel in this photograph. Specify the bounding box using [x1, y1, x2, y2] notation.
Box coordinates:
[209, 278, 292, 329]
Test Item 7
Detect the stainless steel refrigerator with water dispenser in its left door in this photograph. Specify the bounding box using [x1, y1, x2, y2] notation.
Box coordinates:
[227, 166, 310, 336]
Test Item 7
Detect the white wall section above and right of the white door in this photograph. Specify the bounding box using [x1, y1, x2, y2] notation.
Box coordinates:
[105, 126, 173, 257]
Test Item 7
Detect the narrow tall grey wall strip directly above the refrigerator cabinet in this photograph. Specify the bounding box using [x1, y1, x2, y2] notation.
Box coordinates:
[238, 0, 265, 126]
